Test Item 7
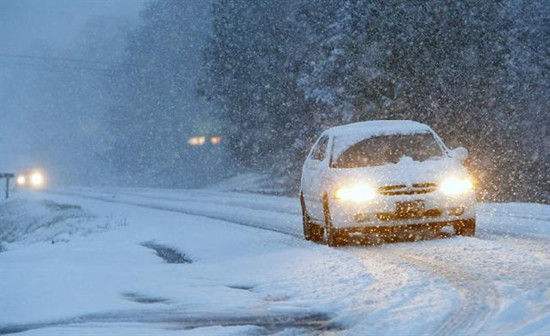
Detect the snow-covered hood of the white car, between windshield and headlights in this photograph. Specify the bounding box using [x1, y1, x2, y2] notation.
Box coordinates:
[331, 158, 467, 187]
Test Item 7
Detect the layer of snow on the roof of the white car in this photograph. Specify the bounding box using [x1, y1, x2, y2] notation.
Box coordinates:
[323, 120, 438, 157]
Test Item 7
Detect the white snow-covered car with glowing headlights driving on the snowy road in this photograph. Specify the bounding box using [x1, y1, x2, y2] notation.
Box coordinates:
[300, 120, 476, 246]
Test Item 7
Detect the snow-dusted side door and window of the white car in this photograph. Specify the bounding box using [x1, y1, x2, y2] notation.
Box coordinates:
[303, 135, 329, 221]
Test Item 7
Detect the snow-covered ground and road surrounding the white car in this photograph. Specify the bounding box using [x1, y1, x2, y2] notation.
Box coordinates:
[0, 188, 550, 335]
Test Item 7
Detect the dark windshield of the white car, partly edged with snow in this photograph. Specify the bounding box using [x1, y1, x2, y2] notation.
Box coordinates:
[332, 133, 443, 168]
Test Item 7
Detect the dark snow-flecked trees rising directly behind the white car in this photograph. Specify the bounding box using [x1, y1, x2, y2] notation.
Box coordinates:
[201, 0, 549, 200]
